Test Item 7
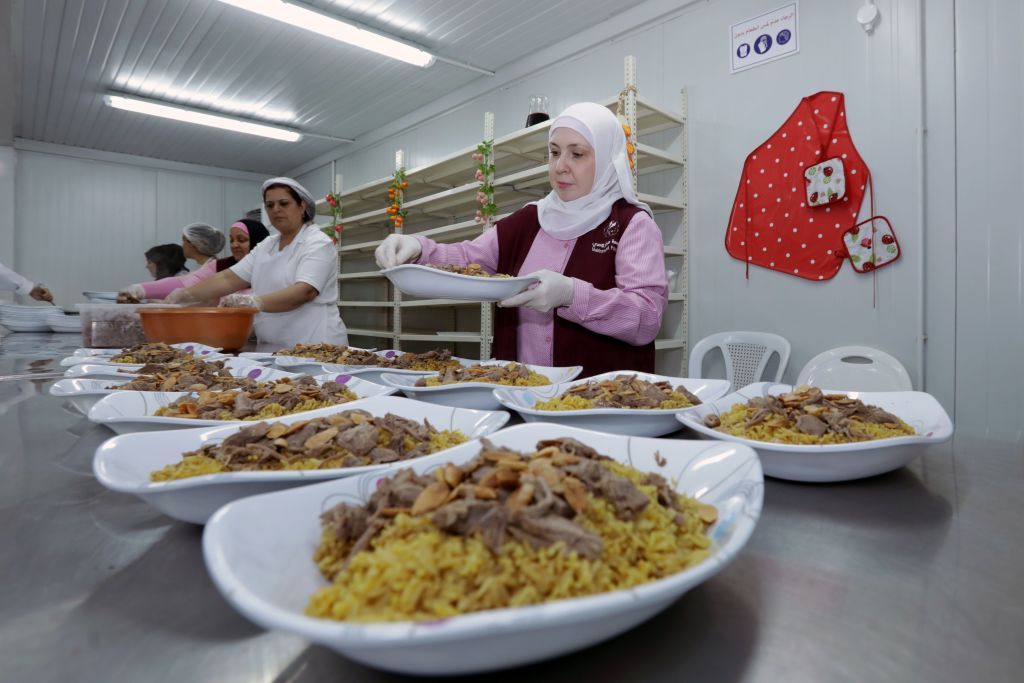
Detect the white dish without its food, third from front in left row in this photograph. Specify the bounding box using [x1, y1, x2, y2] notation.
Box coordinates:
[88, 375, 394, 434]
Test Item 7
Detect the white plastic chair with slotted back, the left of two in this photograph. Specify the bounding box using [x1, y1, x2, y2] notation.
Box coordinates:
[689, 332, 791, 391]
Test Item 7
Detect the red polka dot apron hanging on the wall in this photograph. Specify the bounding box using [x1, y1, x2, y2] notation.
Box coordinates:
[725, 92, 868, 281]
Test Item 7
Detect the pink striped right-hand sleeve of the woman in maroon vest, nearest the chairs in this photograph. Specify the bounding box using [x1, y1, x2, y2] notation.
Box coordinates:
[558, 212, 669, 346]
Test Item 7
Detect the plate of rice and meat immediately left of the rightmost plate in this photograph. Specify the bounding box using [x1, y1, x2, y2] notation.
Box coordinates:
[494, 370, 729, 436]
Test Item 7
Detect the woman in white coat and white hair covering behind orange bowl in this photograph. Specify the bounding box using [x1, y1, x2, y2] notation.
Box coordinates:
[167, 178, 348, 350]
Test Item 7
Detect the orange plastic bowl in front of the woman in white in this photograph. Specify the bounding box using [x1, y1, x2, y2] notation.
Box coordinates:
[138, 307, 259, 351]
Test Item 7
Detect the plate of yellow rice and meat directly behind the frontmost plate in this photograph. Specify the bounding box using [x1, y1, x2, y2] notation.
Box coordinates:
[92, 396, 509, 524]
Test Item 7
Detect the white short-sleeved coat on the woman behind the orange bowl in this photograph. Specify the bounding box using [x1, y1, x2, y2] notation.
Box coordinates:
[231, 223, 348, 350]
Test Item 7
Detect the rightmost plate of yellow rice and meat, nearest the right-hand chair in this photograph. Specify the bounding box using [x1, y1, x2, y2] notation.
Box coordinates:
[677, 382, 953, 481]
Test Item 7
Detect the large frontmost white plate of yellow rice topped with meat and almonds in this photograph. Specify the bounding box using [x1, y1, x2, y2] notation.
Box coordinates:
[203, 423, 763, 676]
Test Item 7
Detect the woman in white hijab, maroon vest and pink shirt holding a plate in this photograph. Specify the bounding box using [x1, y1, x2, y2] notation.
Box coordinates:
[375, 102, 668, 376]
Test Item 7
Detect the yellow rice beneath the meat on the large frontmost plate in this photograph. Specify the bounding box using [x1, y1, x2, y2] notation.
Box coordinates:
[306, 461, 711, 622]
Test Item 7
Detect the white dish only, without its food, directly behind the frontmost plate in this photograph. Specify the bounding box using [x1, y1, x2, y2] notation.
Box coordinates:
[92, 396, 509, 524]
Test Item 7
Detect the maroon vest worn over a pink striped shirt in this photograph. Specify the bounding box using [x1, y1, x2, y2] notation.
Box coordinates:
[492, 199, 654, 377]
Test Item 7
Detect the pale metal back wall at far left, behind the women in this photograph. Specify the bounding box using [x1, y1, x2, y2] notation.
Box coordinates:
[14, 151, 259, 304]
